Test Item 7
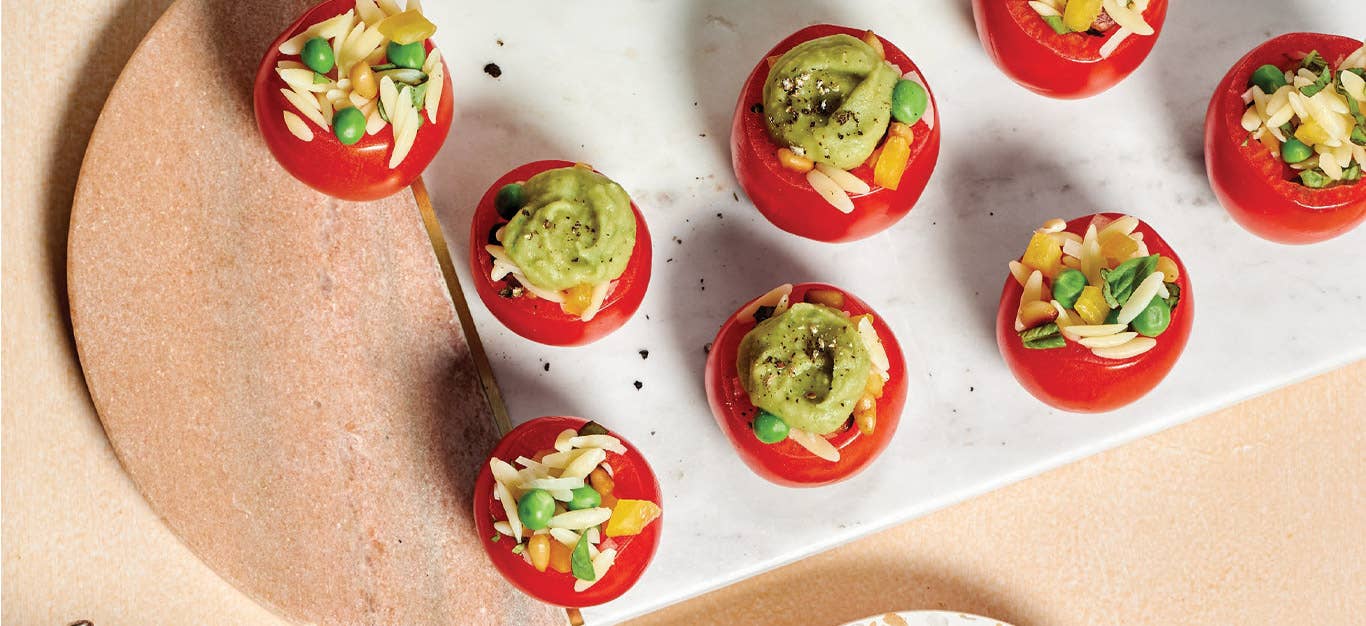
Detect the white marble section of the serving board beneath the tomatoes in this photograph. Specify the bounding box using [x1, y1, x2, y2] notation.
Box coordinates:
[425, 0, 1366, 625]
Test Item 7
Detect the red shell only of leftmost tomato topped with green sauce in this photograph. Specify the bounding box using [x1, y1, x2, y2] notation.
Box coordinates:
[470, 161, 650, 346]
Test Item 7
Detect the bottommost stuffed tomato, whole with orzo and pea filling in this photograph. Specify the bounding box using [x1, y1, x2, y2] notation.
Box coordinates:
[474, 417, 663, 607]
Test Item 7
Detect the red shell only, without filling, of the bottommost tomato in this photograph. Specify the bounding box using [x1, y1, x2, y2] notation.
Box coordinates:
[474, 417, 664, 608]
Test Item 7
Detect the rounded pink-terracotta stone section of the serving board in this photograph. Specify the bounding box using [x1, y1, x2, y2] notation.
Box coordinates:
[68, 0, 566, 625]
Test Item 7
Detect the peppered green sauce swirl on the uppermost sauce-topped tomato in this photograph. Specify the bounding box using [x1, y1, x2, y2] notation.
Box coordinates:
[764, 34, 900, 169]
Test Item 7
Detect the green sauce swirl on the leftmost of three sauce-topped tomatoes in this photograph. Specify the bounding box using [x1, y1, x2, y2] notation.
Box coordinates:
[503, 167, 635, 290]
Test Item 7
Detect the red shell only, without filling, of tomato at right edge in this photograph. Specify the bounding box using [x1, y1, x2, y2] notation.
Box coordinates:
[1205, 33, 1366, 243]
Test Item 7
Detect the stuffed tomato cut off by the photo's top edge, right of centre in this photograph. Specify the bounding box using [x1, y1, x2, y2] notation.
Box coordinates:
[973, 0, 1167, 98]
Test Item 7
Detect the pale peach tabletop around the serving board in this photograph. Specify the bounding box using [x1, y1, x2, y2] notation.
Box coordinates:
[0, 0, 1366, 626]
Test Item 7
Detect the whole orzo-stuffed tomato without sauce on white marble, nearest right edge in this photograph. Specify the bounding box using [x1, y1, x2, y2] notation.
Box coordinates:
[996, 213, 1195, 413]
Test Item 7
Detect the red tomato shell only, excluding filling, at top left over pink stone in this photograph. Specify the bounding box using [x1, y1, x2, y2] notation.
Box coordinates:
[254, 0, 455, 201]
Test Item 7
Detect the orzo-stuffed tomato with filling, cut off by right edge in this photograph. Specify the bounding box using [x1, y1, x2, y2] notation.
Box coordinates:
[1205, 33, 1366, 243]
